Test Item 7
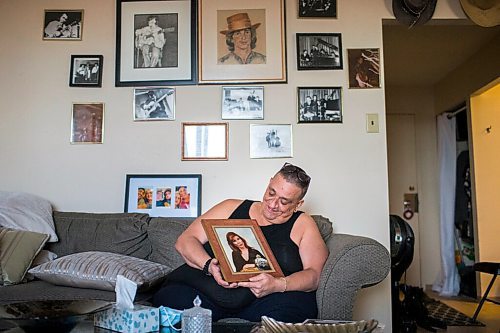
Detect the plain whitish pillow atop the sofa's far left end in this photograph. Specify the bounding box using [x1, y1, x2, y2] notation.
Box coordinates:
[0, 191, 58, 242]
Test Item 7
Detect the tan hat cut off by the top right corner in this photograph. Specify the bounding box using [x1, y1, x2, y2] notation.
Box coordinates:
[460, 0, 500, 28]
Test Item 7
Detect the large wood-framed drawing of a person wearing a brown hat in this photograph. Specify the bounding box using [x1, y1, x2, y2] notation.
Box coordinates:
[198, 0, 287, 84]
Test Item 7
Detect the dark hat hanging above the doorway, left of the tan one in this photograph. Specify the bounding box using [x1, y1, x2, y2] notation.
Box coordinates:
[392, 0, 437, 28]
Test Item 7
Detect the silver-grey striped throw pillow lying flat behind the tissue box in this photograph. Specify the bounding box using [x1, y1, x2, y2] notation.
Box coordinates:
[28, 251, 171, 291]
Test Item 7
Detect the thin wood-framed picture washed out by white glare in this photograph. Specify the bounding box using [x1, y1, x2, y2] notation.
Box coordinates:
[181, 123, 229, 161]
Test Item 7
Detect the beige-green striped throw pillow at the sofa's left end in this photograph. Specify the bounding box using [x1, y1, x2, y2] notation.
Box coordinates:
[0, 227, 50, 285]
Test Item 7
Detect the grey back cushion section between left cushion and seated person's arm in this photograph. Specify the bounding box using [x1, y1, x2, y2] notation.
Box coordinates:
[148, 217, 194, 269]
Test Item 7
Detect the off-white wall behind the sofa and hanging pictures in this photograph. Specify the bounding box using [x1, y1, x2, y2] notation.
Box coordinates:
[0, 0, 463, 326]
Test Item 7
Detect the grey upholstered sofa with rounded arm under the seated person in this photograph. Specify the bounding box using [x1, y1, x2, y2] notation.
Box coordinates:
[0, 212, 390, 320]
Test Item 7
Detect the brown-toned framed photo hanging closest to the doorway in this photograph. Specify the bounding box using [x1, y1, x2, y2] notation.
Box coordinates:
[347, 49, 380, 89]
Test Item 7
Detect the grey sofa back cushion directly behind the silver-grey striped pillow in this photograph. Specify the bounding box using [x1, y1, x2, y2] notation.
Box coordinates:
[46, 211, 151, 259]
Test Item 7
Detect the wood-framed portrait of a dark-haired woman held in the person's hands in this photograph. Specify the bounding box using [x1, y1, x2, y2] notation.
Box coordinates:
[201, 219, 284, 282]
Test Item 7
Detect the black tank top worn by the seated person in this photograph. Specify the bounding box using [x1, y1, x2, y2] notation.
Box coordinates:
[229, 200, 303, 275]
